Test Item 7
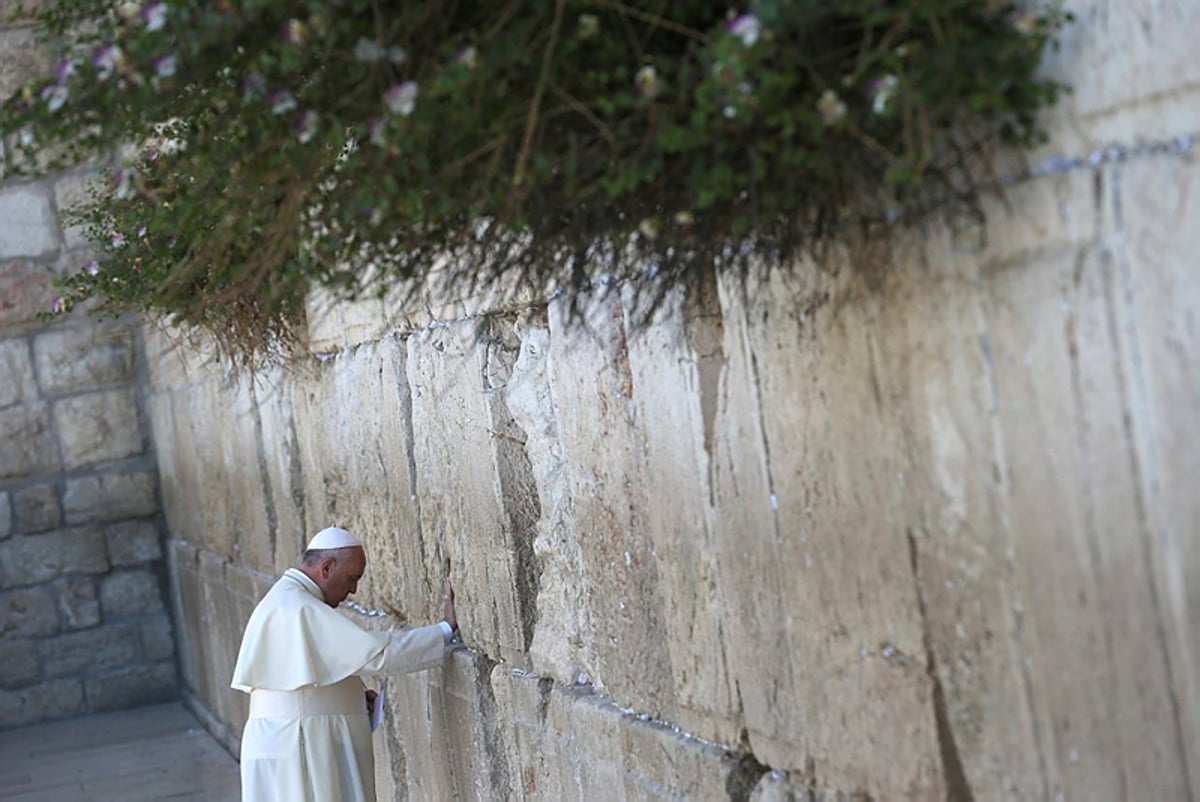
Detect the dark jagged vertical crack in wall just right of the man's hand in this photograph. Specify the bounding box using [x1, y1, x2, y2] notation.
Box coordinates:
[480, 319, 541, 653]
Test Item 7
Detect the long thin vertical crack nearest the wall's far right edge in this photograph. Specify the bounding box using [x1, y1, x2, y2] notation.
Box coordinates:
[1104, 169, 1195, 802]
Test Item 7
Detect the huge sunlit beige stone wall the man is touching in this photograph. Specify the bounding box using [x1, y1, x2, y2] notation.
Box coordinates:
[77, 0, 1200, 800]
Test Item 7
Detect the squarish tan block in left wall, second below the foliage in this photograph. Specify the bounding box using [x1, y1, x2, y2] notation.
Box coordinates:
[54, 390, 142, 469]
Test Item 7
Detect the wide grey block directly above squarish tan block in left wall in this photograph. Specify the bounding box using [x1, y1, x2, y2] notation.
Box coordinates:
[34, 327, 136, 393]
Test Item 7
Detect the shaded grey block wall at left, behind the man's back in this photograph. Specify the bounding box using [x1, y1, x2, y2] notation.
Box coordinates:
[0, 7, 178, 728]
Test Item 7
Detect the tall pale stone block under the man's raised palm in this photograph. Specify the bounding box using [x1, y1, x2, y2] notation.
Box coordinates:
[407, 321, 535, 665]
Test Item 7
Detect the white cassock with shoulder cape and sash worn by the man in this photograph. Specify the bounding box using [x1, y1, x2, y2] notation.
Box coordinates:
[230, 568, 450, 802]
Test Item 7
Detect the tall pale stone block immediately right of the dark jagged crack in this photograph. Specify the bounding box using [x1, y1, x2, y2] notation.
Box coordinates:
[538, 300, 676, 716]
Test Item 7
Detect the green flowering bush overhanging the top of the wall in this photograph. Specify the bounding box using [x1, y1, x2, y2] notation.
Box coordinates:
[0, 0, 1064, 351]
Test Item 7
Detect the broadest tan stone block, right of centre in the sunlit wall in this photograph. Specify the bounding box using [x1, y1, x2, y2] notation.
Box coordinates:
[714, 265, 946, 798]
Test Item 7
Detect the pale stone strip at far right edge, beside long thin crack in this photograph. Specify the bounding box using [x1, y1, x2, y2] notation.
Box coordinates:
[1102, 151, 1200, 797]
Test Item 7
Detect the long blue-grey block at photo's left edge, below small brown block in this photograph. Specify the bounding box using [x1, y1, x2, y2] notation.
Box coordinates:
[0, 527, 108, 587]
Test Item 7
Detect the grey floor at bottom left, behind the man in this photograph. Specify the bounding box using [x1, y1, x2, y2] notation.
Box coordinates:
[0, 702, 240, 802]
